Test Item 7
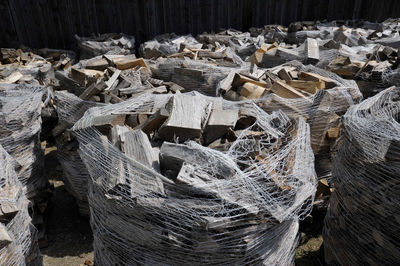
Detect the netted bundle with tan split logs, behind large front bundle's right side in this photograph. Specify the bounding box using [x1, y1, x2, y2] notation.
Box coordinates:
[218, 61, 362, 178]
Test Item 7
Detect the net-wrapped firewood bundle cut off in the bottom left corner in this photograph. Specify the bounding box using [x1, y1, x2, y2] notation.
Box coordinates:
[0, 145, 42, 266]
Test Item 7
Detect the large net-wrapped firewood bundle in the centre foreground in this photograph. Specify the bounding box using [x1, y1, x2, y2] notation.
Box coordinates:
[72, 92, 316, 265]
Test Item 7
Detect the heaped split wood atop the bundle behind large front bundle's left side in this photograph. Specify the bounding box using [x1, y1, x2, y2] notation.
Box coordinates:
[55, 54, 182, 103]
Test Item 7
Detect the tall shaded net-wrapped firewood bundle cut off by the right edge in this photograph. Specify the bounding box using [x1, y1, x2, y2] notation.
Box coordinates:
[323, 87, 400, 265]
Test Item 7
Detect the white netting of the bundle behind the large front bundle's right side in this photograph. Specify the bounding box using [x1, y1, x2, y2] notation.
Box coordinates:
[219, 61, 362, 178]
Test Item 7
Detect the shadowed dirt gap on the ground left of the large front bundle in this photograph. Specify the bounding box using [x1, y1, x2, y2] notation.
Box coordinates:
[41, 149, 93, 266]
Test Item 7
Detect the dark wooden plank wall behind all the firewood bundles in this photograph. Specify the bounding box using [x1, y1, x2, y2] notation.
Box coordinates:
[0, 0, 400, 48]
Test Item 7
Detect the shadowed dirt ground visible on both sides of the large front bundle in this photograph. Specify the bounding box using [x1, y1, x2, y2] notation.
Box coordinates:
[41, 147, 325, 266]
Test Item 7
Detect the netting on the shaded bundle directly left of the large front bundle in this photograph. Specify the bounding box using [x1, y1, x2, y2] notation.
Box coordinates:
[54, 91, 103, 216]
